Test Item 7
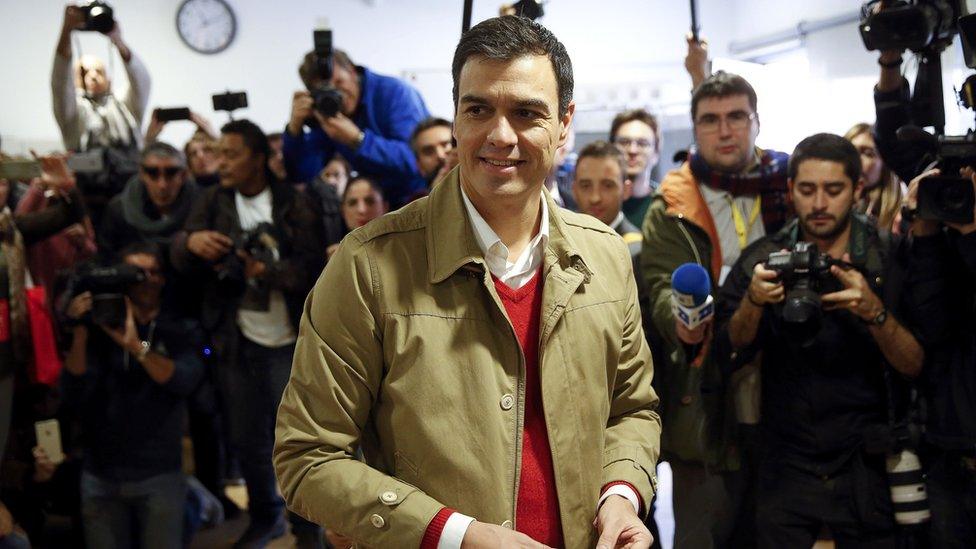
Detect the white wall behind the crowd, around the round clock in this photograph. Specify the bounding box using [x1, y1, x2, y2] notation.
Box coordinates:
[0, 0, 732, 152]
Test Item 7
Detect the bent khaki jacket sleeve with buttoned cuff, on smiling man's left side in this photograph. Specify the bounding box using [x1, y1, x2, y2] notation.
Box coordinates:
[273, 236, 444, 547]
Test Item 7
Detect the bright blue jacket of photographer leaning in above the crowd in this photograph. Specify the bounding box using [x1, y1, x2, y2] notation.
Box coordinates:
[283, 67, 430, 205]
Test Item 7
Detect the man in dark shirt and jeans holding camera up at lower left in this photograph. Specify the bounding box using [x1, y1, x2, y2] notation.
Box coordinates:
[62, 243, 203, 547]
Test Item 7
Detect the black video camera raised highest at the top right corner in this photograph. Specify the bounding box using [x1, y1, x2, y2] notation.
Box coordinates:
[858, 0, 960, 53]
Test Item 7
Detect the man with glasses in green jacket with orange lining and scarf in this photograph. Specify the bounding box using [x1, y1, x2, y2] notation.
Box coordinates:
[641, 71, 790, 549]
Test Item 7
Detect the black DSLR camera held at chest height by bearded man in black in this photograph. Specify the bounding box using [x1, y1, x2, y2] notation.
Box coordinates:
[766, 242, 848, 343]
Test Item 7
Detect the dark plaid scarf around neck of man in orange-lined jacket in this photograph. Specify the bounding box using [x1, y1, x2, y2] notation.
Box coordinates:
[688, 149, 793, 234]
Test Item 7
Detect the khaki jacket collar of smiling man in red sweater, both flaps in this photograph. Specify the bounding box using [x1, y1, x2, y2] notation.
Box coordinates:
[426, 167, 592, 284]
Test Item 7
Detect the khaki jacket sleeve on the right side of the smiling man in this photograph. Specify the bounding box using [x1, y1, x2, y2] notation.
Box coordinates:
[603, 241, 661, 514]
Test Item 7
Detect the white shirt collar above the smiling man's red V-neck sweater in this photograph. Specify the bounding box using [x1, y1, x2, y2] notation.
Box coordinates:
[461, 187, 549, 288]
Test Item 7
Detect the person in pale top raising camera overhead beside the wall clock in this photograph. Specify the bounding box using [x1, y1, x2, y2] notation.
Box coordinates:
[51, 5, 150, 151]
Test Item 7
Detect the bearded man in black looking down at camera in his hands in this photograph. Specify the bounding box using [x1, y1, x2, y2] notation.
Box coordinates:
[715, 134, 923, 547]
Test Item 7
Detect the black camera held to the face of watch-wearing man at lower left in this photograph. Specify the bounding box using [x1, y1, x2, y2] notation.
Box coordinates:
[68, 263, 147, 328]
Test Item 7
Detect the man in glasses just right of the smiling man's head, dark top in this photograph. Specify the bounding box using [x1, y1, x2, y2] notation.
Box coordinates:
[610, 109, 661, 227]
